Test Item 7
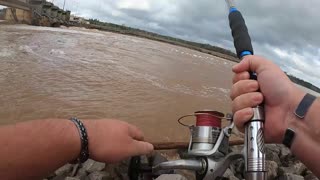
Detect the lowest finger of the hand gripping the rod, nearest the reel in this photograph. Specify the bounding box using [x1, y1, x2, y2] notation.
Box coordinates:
[233, 108, 253, 132]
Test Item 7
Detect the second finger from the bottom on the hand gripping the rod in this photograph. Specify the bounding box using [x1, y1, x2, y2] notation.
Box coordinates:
[232, 92, 263, 113]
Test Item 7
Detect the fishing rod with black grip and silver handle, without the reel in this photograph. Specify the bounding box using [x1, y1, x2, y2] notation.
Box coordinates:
[226, 0, 266, 180]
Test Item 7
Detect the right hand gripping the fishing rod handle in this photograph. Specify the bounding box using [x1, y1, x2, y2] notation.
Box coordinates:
[230, 56, 304, 143]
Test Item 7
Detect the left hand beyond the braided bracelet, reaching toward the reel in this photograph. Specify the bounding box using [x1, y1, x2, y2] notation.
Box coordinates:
[83, 120, 153, 163]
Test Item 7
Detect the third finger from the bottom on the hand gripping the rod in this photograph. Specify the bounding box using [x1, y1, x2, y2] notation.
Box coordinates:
[230, 80, 259, 100]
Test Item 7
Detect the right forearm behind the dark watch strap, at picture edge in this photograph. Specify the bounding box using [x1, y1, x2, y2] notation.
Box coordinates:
[289, 95, 320, 177]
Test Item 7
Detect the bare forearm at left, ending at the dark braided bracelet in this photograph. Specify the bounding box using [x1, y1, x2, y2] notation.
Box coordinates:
[0, 119, 80, 179]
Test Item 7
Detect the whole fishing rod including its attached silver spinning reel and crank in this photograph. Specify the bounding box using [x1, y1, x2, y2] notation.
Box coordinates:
[128, 0, 266, 180]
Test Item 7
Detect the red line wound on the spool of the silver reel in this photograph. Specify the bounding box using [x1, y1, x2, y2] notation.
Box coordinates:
[195, 111, 224, 128]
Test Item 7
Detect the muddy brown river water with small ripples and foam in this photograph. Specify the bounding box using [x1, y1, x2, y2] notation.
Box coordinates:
[0, 25, 238, 141]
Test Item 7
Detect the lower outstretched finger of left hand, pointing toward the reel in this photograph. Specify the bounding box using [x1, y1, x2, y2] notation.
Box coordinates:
[129, 140, 153, 156]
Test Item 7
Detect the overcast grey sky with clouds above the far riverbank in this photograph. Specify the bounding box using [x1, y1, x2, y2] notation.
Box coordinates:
[2, 0, 320, 87]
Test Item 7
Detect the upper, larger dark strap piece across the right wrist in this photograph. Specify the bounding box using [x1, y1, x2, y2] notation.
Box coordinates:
[294, 93, 317, 119]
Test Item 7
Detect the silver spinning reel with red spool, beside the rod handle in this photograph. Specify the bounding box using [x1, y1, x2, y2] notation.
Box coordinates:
[153, 110, 243, 180]
